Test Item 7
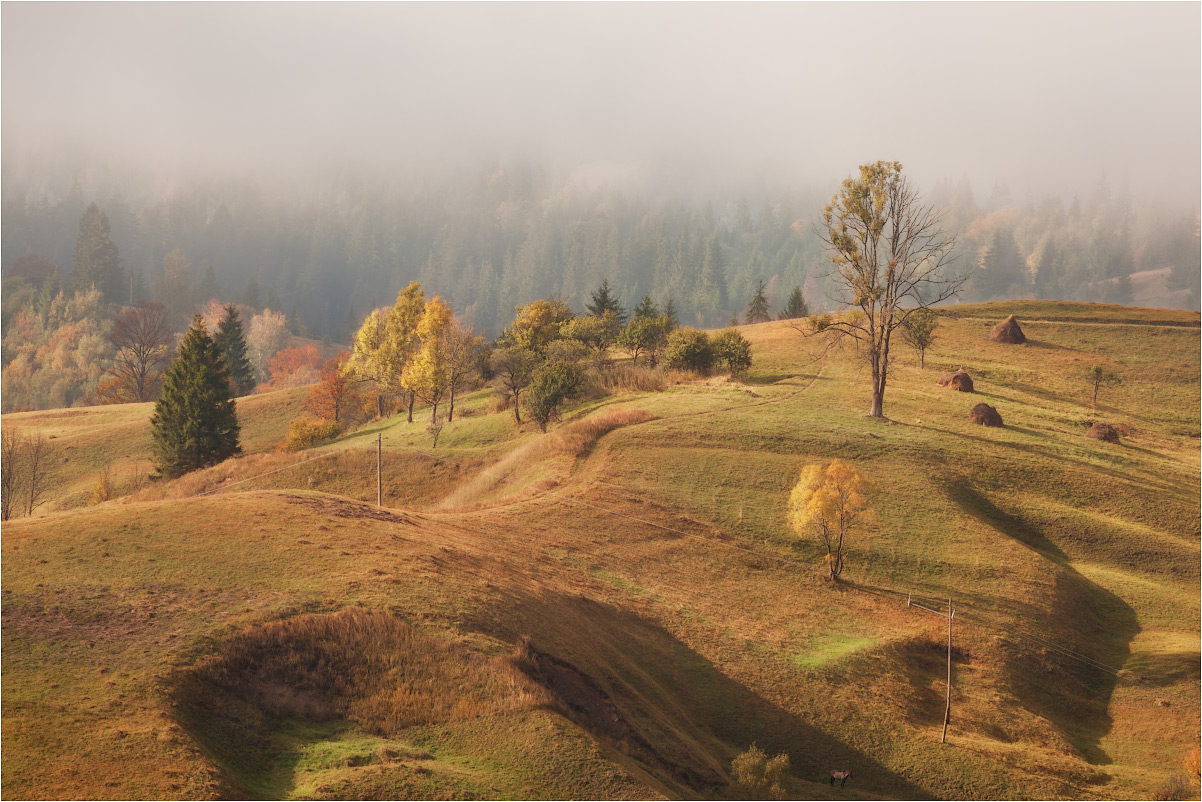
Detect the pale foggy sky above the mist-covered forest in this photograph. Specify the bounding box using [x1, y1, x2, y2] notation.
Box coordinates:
[0, 2, 1202, 204]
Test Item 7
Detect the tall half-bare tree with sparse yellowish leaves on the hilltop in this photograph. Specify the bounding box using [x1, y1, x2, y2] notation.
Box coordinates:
[803, 161, 968, 417]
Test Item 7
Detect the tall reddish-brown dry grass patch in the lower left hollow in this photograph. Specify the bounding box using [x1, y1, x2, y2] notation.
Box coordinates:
[172, 608, 551, 747]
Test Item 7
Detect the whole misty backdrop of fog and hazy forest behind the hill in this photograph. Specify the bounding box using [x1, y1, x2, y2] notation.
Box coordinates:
[0, 4, 1202, 409]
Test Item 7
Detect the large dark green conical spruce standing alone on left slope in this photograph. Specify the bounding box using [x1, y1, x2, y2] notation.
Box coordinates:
[150, 315, 242, 477]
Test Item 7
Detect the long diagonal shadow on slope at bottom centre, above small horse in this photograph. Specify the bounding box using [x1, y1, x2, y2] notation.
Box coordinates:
[464, 588, 932, 798]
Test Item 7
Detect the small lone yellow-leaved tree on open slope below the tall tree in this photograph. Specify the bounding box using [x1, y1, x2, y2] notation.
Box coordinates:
[789, 459, 870, 582]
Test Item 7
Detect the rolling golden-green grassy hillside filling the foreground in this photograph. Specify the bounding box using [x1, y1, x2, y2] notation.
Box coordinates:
[2, 302, 1202, 798]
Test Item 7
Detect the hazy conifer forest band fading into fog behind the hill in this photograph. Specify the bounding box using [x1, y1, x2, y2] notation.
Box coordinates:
[0, 166, 1200, 409]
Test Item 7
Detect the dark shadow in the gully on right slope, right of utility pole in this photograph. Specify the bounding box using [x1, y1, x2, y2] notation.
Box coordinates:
[948, 479, 1139, 765]
